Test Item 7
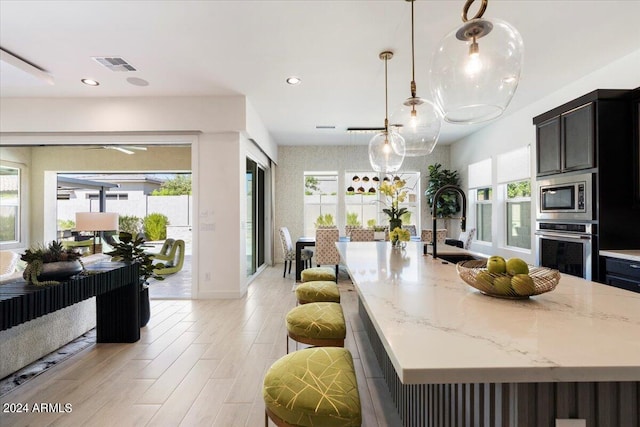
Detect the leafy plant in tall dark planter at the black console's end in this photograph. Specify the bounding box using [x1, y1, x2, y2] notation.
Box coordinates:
[106, 231, 164, 327]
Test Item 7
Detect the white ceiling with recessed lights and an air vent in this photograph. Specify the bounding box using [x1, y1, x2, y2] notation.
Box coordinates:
[0, 0, 640, 145]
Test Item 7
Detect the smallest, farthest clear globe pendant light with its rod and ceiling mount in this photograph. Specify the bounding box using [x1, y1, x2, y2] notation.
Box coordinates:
[369, 51, 405, 173]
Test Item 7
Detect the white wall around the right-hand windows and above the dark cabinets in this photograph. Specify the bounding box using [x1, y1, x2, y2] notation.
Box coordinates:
[451, 50, 640, 264]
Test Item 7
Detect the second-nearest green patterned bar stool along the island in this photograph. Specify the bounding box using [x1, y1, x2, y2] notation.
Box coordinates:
[286, 302, 347, 353]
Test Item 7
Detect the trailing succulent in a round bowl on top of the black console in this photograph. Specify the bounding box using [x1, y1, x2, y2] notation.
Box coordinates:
[20, 240, 84, 286]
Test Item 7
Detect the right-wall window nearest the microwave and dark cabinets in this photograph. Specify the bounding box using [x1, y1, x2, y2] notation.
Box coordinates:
[506, 180, 531, 249]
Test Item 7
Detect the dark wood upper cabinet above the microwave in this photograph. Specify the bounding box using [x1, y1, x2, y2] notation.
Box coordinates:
[533, 89, 629, 176]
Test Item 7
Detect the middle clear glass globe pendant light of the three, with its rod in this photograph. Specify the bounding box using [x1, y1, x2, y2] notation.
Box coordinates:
[391, 0, 442, 157]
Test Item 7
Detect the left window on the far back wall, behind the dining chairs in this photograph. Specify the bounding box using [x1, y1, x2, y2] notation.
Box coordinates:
[304, 172, 338, 236]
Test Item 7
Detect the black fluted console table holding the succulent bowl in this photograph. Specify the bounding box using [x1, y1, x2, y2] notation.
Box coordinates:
[0, 262, 140, 343]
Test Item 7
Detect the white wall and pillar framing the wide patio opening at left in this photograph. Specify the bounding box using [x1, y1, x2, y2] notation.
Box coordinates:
[0, 97, 277, 298]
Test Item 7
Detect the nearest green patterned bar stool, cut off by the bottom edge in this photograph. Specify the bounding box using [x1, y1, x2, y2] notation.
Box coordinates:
[262, 347, 362, 427]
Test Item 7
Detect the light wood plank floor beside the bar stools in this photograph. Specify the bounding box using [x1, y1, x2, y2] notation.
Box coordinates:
[0, 265, 401, 427]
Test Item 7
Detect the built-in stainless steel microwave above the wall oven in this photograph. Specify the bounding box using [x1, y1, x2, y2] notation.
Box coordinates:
[537, 174, 596, 221]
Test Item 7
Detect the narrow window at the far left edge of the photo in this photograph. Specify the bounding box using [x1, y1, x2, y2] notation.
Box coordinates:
[0, 166, 20, 243]
